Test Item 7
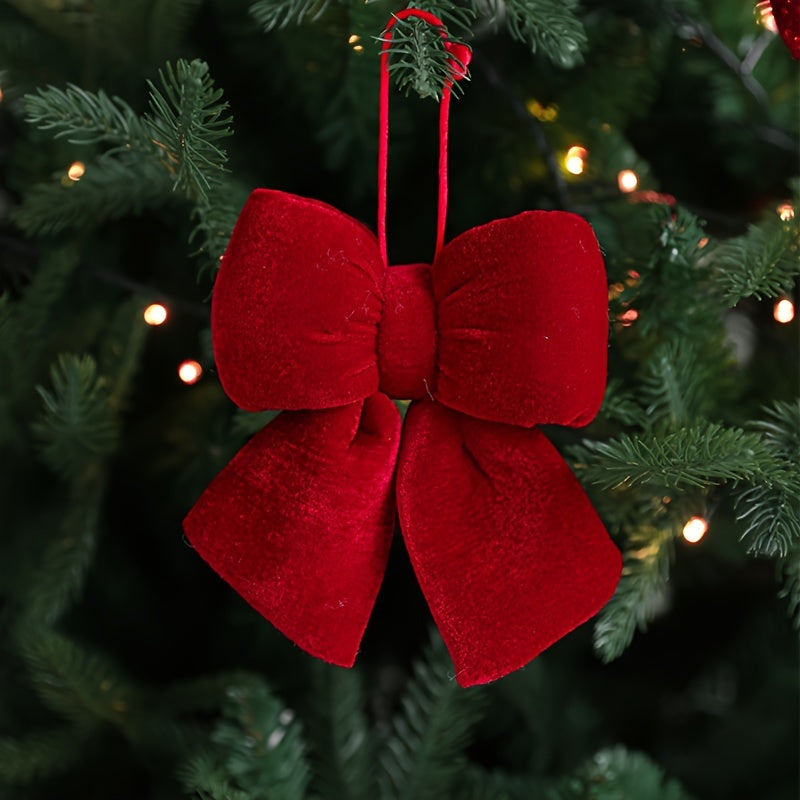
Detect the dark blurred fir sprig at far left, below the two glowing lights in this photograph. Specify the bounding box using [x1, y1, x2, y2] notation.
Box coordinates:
[33, 354, 117, 476]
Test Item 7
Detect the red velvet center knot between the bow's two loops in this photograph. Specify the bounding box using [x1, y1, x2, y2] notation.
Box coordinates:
[378, 264, 436, 400]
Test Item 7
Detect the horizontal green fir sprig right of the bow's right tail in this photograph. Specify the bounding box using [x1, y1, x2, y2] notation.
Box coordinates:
[571, 422, 772, 489]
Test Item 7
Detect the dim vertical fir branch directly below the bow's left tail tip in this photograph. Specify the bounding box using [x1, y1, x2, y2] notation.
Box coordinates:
[308, 664, 377, 800]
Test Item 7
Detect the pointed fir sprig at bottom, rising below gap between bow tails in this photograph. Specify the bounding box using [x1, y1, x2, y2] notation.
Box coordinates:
[380, 637, 483, 800]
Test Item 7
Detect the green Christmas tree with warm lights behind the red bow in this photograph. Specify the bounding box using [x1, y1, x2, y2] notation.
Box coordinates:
[0, 0, 800, 800]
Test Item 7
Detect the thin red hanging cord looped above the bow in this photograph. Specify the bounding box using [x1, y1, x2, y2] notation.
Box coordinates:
[378, 8, 471, 267]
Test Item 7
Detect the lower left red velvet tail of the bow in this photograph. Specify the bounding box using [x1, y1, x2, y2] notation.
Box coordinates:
[184, 394, 400, 667]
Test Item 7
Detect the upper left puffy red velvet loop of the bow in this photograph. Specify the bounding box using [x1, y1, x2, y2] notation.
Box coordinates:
[211, 189, 385, 411]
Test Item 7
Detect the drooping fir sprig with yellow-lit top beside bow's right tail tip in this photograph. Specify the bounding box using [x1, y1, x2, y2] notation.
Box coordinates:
[594, 527, 673, 664]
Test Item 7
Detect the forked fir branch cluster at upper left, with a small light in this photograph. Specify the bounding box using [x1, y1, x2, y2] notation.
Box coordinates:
[15, 59, 235, 242]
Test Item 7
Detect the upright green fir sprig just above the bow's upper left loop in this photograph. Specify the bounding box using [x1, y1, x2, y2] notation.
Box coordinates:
[146, 59, 231, 198]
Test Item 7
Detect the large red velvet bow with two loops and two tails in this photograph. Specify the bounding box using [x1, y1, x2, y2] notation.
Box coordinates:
[185, 189, 621, 686]
